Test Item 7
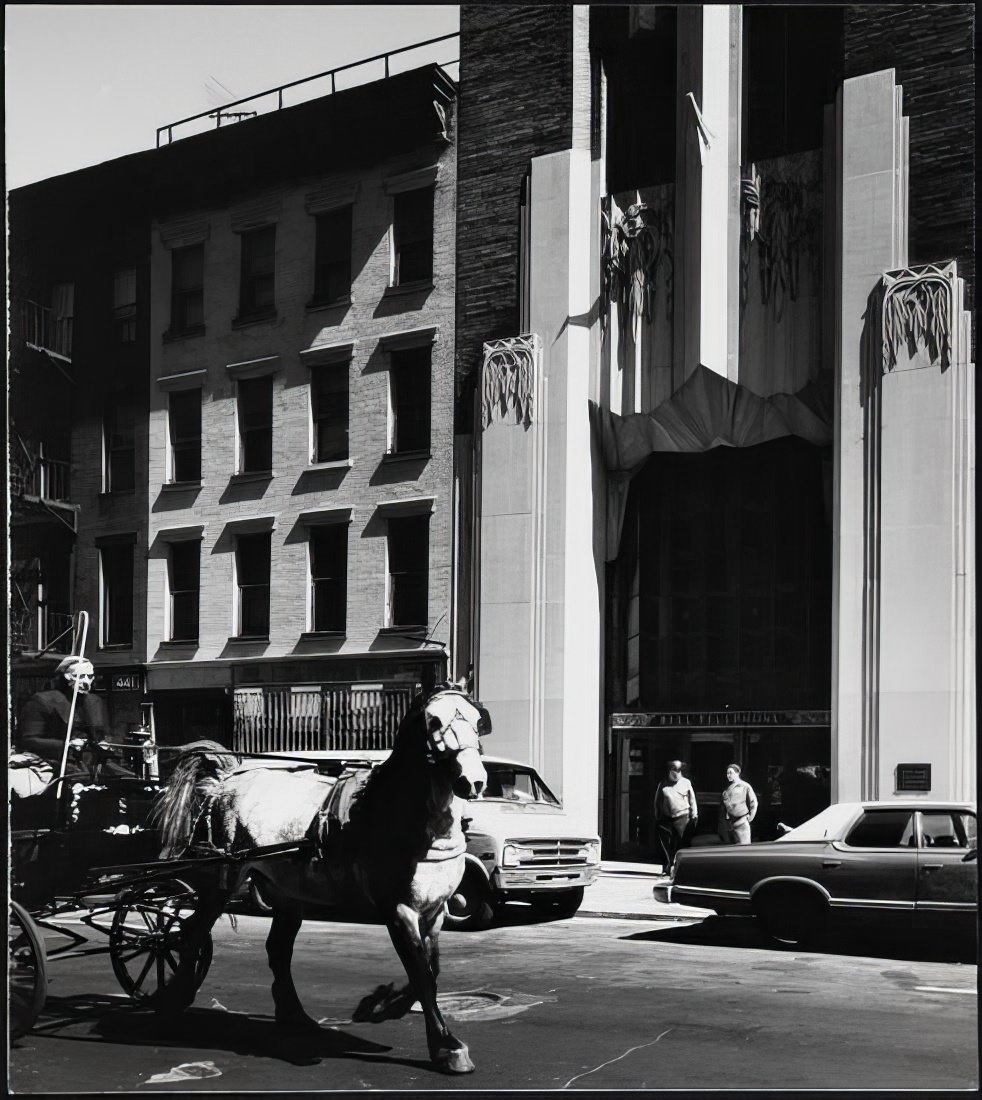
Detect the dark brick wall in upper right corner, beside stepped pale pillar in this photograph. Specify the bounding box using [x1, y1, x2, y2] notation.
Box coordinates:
[843, 4, 975, 347]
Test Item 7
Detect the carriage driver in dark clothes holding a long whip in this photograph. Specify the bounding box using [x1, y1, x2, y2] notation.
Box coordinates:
[18, 657, 133, 779]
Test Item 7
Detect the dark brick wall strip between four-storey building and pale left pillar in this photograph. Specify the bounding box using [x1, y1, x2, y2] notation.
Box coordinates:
[456, 4, 574, 428]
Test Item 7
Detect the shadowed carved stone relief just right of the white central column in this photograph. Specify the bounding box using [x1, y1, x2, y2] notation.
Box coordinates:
[740, 150, 821, 321]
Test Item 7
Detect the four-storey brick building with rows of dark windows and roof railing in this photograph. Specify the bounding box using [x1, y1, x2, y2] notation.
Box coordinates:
[11, 58, 456, 749]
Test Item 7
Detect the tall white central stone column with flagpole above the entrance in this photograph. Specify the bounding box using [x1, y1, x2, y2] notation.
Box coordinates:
[673, 4, 742, 389]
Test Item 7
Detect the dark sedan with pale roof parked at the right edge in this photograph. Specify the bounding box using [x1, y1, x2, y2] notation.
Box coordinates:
[654, 801, 979, 944]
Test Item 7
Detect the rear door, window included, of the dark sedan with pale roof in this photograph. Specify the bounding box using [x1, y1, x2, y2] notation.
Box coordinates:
[818, 807, 917, 931]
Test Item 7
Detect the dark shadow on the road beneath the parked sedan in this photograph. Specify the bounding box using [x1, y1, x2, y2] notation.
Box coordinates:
[620, 916, 978, 964]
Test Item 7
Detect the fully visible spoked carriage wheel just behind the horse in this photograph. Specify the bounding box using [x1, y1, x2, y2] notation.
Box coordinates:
[109, 879, 212, 1004]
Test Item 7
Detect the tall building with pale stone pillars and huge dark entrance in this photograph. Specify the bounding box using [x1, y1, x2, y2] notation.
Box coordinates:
[456, 4, 975, 844]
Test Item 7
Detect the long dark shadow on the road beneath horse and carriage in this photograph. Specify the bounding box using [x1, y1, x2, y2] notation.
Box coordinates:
[27, 994, 432, 1069]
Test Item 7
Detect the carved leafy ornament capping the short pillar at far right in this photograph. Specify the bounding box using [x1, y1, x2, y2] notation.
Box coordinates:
[882, 263, 956, 374]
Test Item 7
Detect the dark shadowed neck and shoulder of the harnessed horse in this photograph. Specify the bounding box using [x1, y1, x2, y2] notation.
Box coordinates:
[345, 685, 453, 897]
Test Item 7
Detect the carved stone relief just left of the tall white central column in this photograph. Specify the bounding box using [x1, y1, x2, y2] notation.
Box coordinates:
[600, 193, 675, 329]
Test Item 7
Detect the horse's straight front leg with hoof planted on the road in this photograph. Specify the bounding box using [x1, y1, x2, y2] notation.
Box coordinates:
[387, 904, 474, 1074]
